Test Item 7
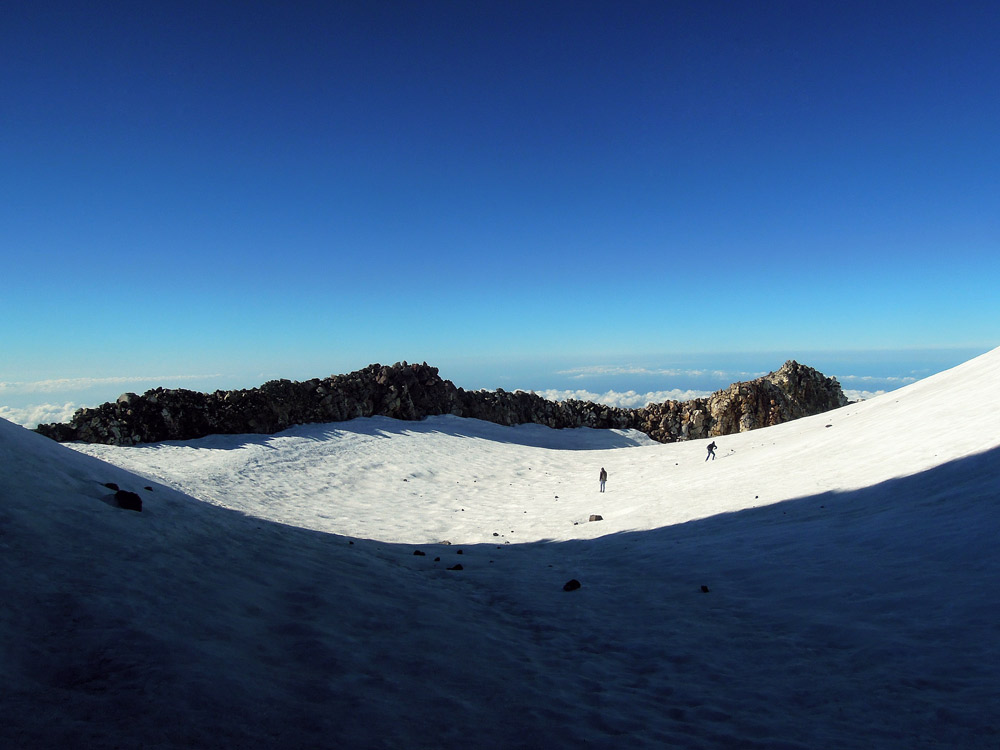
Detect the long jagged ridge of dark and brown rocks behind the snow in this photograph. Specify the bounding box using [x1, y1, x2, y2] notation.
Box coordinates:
[37, 360, 847, 445]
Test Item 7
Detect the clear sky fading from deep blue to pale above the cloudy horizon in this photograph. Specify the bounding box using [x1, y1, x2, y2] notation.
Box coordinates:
[0, 0, 1000, 424]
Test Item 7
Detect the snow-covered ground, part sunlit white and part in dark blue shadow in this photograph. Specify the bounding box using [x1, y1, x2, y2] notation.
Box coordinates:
[0, 349, 1000, 750]
